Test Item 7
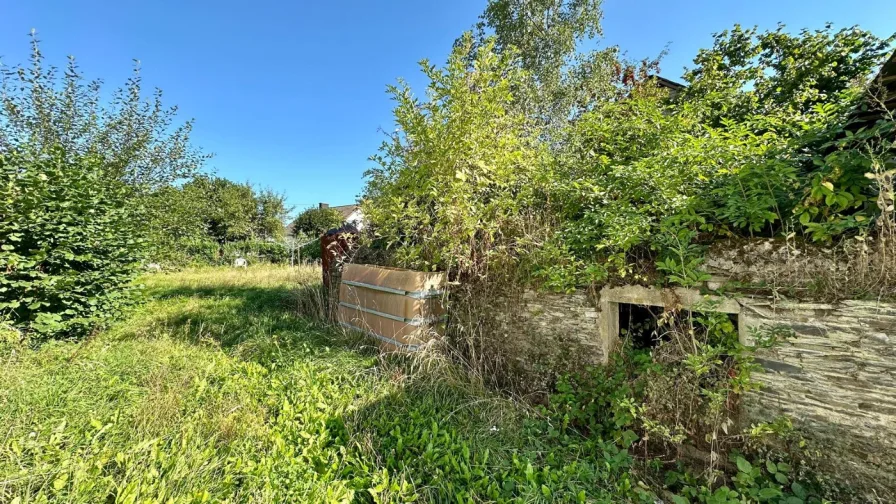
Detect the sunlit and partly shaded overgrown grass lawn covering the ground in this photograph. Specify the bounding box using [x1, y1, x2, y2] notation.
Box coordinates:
[0, 267, 638, 503]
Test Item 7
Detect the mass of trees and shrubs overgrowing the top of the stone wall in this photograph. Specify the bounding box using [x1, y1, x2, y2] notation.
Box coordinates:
[364, 11, 896, 289]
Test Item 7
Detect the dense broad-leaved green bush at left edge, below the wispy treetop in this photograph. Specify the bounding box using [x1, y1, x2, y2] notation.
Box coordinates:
[0, 148, 143, 337]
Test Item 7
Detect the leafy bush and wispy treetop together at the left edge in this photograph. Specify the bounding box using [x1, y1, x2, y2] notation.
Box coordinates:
[0, 34, 206, 337]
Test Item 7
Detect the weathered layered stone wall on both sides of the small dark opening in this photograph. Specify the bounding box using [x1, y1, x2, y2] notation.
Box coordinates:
[500, 286, 896, 500]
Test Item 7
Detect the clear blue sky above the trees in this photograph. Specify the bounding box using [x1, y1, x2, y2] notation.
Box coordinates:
[0, 0, 896, 214]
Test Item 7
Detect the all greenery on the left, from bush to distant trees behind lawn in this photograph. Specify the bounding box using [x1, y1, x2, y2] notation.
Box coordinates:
[0, 35, 290, 337]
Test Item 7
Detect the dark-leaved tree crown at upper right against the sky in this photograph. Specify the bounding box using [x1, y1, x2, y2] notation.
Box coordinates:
[683, 23, 896, 126]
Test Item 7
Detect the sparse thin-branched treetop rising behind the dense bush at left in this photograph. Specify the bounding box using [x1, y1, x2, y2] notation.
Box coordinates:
[0, 32, 208, 192]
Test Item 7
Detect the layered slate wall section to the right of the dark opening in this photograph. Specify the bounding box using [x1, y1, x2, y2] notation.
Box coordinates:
[738, 298, 896, 497]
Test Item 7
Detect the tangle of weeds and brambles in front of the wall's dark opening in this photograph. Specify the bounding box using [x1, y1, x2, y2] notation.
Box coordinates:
[544, 303, 821, 504]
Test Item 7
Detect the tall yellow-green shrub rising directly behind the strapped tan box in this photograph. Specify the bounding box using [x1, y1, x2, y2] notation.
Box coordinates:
[363, 34, 548, 273]
